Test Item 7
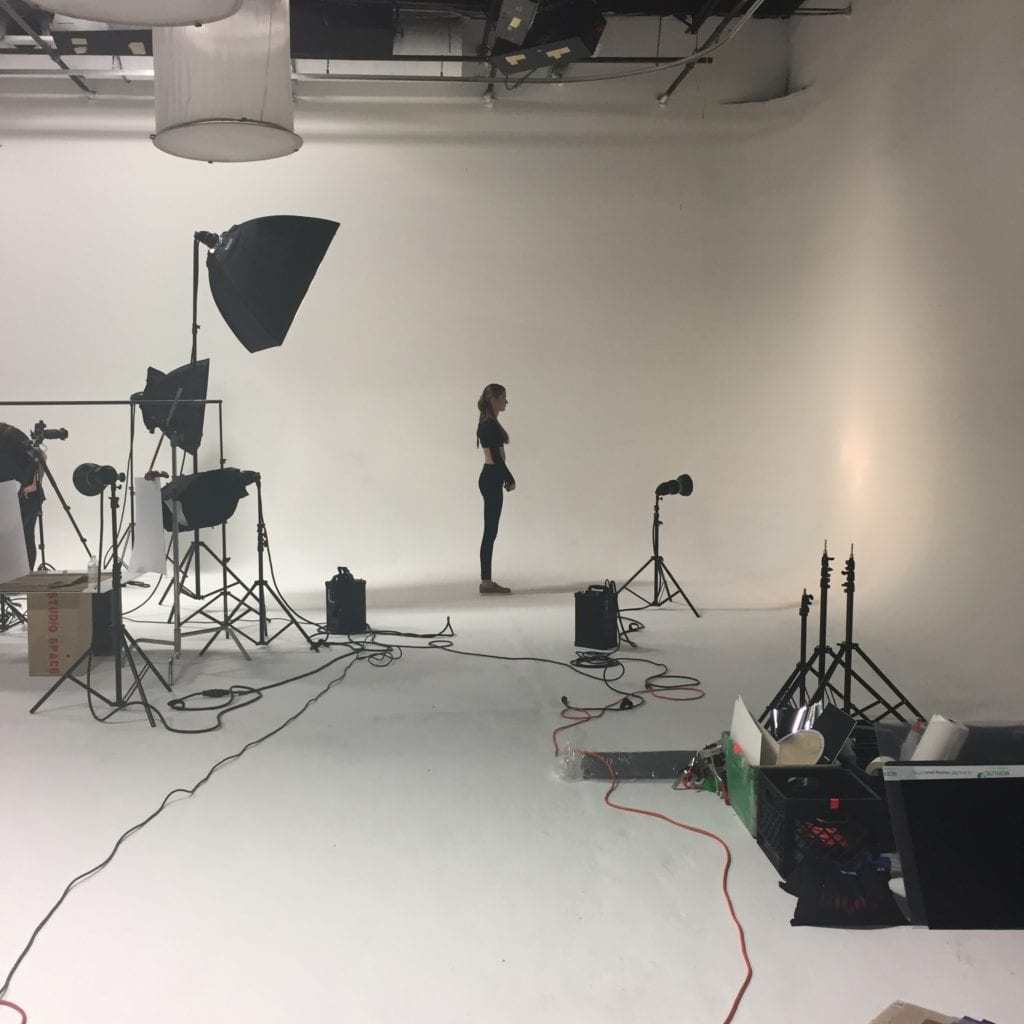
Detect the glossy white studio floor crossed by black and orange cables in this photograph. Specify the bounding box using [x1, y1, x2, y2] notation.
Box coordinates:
[0, 582, 1024, 1024]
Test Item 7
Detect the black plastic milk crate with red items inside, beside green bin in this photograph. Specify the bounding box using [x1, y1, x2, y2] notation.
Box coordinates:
[758, 765, 889, 878]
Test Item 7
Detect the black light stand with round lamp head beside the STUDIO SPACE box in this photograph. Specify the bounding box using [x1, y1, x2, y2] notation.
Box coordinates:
[30, 463, 170, 726]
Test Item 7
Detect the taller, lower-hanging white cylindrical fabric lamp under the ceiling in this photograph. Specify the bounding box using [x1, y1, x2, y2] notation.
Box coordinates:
[153, 0, 302, 163]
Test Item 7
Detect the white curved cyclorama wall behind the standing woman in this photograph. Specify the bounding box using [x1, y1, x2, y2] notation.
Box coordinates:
[0, 0, 1024, 708]
